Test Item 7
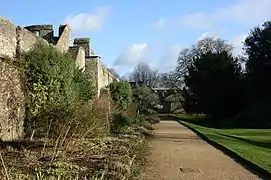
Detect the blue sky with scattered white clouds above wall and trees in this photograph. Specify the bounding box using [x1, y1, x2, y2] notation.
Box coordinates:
[0, 0, 271, 75]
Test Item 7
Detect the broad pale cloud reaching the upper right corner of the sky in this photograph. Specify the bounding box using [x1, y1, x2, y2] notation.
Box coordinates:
[181, 0, 271, 28]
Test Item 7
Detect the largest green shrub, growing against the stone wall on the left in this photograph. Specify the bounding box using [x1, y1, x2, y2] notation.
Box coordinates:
[21, 43, 93, 135]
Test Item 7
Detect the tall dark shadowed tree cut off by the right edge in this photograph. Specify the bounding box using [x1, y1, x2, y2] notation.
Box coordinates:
[230, 21, 271, 127]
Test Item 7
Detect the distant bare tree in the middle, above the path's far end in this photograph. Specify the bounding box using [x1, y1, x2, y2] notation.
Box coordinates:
[129, 62, 160, 87]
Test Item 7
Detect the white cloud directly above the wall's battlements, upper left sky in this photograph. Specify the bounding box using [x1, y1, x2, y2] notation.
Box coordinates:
[64, 6, 110, 33]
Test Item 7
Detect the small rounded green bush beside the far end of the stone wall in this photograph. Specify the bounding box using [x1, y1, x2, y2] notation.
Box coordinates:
[109, 81, 132, 111]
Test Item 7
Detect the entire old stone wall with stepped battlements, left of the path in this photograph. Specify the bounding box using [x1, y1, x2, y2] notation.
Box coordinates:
[0, 17, 118, 140]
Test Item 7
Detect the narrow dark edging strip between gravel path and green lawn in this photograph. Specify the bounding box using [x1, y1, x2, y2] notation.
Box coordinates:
[171, 115, 271, 180]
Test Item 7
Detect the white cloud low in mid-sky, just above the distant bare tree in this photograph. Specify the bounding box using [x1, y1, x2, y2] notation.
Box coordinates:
[113, 42, 149, 68]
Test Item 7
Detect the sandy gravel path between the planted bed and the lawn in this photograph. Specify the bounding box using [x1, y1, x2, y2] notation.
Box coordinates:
[140, 120, 260, 180]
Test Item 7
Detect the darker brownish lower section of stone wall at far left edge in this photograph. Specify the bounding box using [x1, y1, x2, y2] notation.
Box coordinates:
[0, 58, 24, 140]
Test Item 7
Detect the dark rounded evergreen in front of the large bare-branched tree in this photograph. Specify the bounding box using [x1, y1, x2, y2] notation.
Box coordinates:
[185, 52, 242, 117]
